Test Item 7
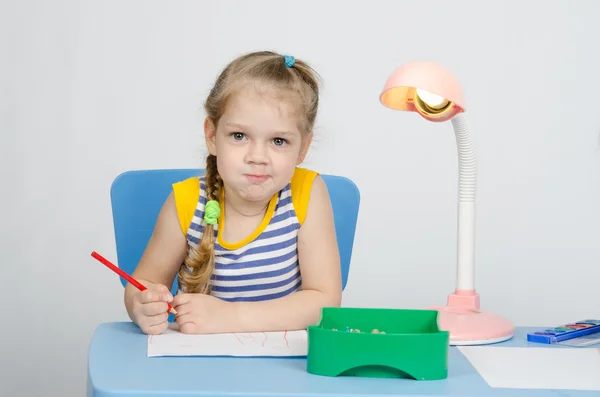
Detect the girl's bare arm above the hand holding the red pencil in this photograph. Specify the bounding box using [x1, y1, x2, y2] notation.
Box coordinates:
[124, 193, 187, 319]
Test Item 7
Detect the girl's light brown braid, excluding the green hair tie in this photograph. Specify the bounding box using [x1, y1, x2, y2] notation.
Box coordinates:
[178, 154, 222, 294]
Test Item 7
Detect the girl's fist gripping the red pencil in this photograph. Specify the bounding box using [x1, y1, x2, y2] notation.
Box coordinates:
[132, 284, 173, 335]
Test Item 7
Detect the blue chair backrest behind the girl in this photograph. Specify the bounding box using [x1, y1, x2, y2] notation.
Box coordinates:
[110, 168, 360, 293]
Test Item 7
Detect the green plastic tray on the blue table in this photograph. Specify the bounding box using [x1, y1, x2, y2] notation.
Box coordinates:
[307, 307, 449, 380]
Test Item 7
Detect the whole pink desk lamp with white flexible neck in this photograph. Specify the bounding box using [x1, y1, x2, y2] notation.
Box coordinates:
[379, 61, 514, 345]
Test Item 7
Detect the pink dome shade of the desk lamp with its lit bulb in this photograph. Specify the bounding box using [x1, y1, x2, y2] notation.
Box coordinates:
[379, 61, 466, 122]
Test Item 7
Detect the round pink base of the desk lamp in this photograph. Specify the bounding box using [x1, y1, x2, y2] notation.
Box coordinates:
[430, 290, 515, 345]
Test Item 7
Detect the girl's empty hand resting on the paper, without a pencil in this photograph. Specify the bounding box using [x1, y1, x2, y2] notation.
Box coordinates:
[172, 294, 234, 334]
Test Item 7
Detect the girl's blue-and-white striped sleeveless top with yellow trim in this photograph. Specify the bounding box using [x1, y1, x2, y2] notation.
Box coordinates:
[174, 169, 316, 302]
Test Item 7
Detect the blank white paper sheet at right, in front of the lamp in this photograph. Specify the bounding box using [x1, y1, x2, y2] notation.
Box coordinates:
[459, 346, 600, 390]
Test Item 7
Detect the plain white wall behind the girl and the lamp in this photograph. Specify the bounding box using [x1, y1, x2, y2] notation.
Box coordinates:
[0, 0, 600, 396]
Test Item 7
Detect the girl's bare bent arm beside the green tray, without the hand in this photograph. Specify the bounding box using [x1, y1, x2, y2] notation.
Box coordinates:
[230, 176, 342, 332]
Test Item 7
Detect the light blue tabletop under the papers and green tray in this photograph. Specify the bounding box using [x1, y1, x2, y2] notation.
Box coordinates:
[87, 322, 600, 397]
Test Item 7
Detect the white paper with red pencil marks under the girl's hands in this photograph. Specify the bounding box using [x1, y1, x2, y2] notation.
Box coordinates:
[148, 326, 308, 357]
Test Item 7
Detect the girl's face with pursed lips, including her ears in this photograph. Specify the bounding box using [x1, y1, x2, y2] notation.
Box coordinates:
[205, 85, 312, 202]
